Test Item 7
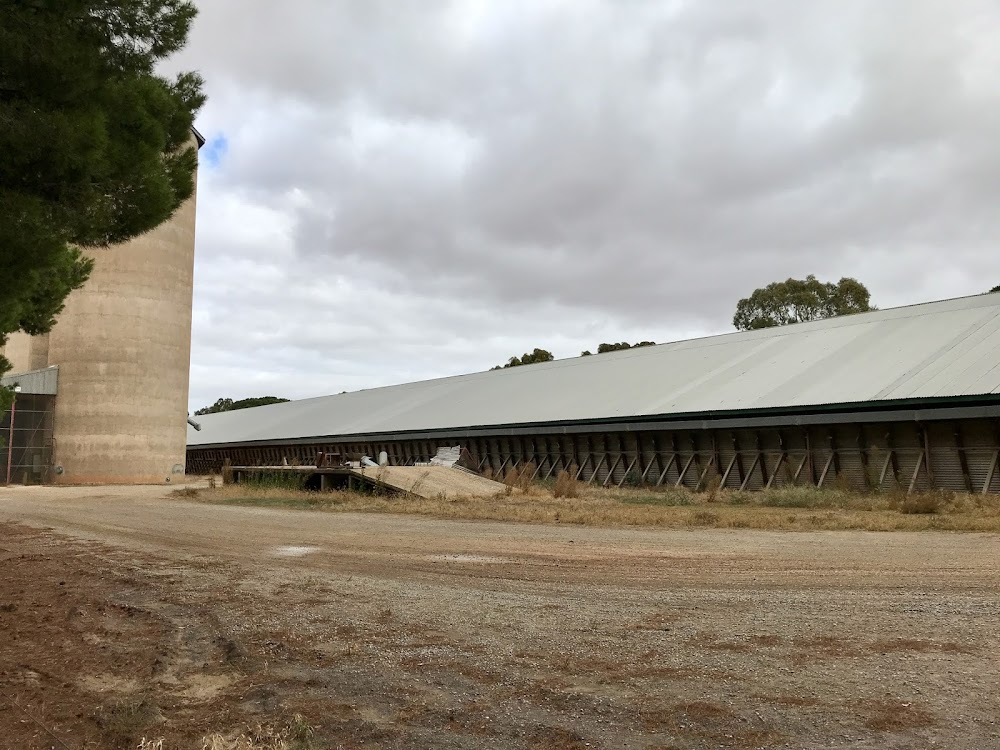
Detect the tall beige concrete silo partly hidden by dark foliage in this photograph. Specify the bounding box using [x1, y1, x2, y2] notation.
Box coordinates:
[5, 137, 201, 484]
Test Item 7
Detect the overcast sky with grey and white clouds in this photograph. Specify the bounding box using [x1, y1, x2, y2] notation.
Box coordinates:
[175, 0, 1000, 408]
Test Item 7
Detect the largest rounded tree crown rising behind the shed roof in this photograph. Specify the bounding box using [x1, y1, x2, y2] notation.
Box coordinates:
[733, 275, 876, 331]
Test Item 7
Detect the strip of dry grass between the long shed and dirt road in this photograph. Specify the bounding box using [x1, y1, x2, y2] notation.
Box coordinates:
[188, 476, 1000, 532]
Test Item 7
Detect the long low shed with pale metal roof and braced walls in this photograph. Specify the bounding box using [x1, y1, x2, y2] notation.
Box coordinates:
[187, 294, 1000, 493]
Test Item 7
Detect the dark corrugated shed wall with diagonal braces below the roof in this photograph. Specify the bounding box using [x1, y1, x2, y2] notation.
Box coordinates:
[187, 419, 1000, 492]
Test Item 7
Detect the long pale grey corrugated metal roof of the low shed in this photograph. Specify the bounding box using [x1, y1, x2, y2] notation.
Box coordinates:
[188, 294, 1000, 446]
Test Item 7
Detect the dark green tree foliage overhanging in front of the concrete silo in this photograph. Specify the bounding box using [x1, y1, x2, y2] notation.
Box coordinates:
[0, 0, 204, 382]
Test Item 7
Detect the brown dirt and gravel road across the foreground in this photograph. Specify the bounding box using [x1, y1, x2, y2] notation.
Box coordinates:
[0, 488, 1000, 750]
